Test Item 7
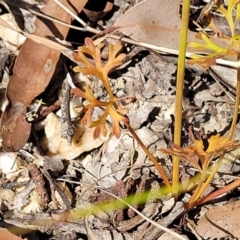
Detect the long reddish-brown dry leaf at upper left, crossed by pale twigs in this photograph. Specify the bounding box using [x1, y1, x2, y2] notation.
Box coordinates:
[0, 0, 87, 151]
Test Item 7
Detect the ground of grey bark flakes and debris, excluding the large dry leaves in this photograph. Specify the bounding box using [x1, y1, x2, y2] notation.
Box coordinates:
[0, 0, 240, 240]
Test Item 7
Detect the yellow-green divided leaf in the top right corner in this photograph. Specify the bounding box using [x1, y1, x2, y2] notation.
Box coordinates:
[188, 0, 240, 70]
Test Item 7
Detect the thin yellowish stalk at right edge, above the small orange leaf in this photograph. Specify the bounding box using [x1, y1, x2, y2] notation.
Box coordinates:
[228, 55, 240, 138]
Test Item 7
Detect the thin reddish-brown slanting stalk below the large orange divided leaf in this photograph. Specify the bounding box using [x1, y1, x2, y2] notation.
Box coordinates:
[124, 123, 171, 189]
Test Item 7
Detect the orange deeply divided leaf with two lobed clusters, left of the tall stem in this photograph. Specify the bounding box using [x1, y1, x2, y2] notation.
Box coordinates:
[72, 38, 128, 139]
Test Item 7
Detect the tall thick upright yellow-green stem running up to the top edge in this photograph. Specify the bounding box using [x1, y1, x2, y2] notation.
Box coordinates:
[172, 0, 190, 198]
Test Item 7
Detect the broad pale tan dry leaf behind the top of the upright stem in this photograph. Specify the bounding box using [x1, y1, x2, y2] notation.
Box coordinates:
[114, 0, 231, 52]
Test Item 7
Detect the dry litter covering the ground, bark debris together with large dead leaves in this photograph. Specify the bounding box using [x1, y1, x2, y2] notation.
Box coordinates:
[0, 0, 239, 240]
